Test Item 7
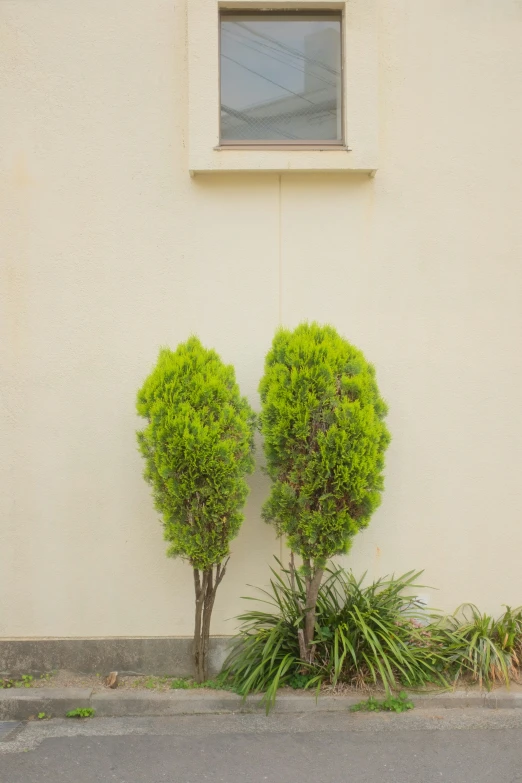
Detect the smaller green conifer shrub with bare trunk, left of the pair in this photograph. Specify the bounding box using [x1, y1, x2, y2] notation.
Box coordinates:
[137, 337, 255, 682]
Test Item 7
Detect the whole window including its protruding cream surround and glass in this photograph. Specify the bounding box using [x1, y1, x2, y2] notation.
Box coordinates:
[186, 0, 379, 176]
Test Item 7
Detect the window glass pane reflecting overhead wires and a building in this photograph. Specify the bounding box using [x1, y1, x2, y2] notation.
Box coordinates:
[221, 14, 342, 144]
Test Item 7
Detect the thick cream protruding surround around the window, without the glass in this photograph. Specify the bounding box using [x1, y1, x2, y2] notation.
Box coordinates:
[187, 0, 380, 178]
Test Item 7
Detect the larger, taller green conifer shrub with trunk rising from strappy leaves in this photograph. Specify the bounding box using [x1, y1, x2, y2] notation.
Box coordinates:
[259, 323, 390, 661]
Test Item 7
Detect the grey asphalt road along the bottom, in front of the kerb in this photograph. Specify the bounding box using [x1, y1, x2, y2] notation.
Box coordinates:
[0, 709, 522, 783]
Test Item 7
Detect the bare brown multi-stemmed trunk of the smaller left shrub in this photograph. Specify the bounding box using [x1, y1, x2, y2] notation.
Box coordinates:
[193, 560, 228, 682]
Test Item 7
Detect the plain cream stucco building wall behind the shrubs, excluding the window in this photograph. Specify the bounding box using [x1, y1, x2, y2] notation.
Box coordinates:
[0, 0, 522, 636]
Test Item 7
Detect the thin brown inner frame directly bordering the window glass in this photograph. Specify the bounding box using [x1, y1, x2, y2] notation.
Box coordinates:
[216, 8, 346, 150]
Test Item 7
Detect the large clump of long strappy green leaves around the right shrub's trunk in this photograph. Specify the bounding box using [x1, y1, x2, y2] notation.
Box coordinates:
[221, 564, 449, 709]
